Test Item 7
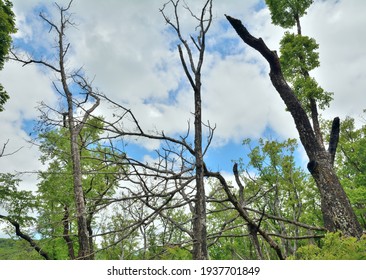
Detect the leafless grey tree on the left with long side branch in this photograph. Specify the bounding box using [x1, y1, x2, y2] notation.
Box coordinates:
[11, 0, 100, 259]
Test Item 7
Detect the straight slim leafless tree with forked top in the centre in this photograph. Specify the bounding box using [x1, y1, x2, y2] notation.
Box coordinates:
[161, 0, 212, 259]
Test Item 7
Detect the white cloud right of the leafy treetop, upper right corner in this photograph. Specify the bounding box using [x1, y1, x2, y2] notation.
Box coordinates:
[303, 0, 366, 121]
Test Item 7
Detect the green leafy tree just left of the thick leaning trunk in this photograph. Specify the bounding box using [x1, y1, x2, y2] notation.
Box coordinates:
[242, 139, 322, 256]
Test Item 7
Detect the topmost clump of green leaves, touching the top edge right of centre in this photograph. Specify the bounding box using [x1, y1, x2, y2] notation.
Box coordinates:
[266, 0, 313, 28]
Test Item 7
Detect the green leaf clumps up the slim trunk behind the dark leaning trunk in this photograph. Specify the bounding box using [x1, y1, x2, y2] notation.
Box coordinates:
[266, 0, 333, 113]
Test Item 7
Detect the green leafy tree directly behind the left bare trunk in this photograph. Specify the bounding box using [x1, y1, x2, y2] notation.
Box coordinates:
[38, 118, 125, 259]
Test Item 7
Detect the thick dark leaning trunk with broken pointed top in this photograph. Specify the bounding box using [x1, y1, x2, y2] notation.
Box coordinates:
[226, 15, 362, 237]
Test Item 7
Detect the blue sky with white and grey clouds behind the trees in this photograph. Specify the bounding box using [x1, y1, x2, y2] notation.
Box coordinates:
[0, 0, 366, 197]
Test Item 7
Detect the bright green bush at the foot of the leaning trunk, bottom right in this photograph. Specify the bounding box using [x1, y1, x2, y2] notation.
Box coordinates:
[289, 233, 366, 260]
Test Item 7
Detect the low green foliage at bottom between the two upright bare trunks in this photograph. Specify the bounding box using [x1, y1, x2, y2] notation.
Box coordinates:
[97, 206, 192, 260]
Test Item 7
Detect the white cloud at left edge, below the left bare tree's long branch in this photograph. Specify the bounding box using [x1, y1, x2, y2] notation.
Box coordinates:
[0, 62, 56, 189]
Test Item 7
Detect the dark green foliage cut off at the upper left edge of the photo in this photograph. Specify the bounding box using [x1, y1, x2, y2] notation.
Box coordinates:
[0, 0, 17, 112]
